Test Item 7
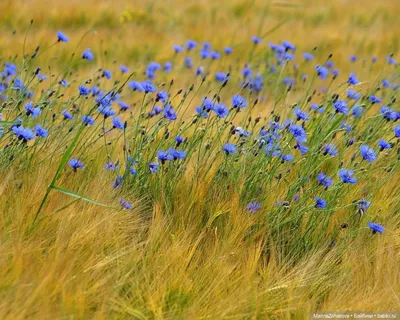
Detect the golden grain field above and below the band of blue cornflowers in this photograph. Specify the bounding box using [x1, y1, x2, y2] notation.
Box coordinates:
[0, 0, 400, 319]
